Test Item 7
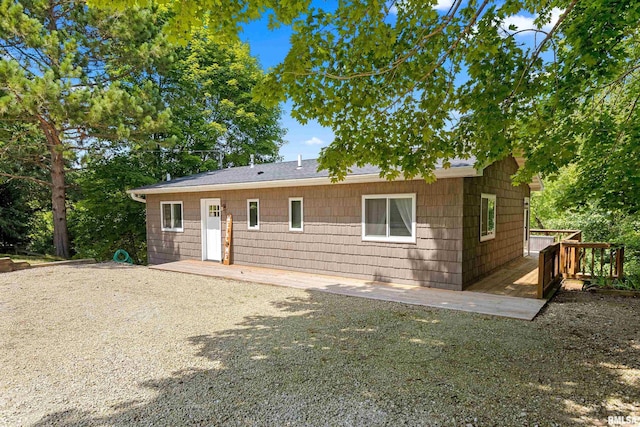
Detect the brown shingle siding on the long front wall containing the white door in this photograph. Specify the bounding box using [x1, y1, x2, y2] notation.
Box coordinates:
[147, 178, 463, 289]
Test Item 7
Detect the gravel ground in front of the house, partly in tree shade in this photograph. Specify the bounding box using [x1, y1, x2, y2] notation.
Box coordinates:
[0, 263, 640, 426]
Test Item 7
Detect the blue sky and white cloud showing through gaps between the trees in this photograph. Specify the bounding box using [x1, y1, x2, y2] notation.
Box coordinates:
[241, 0, 560, 161]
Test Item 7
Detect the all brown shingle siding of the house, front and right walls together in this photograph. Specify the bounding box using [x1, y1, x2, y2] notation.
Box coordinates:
[142, 158, 529, 290]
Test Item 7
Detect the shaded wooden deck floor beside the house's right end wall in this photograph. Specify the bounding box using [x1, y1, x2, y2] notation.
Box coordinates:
[466, 254, 538, 298]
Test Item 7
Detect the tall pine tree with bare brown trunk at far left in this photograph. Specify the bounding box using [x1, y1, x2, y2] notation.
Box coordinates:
[0, 0, 169, 257]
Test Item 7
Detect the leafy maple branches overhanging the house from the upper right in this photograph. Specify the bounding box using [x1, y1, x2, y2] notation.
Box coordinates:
[91, 0, 640, 184]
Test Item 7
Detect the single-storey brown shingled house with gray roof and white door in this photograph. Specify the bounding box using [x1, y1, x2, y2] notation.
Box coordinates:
[130, 157, 540, 290]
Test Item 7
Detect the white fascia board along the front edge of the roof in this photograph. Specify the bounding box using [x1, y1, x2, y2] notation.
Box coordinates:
[127, 166, 482, 195]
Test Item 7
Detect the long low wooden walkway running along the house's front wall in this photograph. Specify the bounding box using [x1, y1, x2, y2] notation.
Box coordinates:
[150, 261, 546, 320]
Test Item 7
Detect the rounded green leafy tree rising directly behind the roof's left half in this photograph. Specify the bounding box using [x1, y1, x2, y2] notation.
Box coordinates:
[154, 32, 284, 176]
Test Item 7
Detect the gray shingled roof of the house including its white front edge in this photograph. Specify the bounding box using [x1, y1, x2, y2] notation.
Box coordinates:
[128, 158, 482, 194]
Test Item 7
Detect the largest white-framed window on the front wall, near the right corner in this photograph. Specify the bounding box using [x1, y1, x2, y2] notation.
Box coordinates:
[362, 194, 416, 243]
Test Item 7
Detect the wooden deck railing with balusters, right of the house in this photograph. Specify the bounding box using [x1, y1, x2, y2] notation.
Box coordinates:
[531, 230, 624, 298]
